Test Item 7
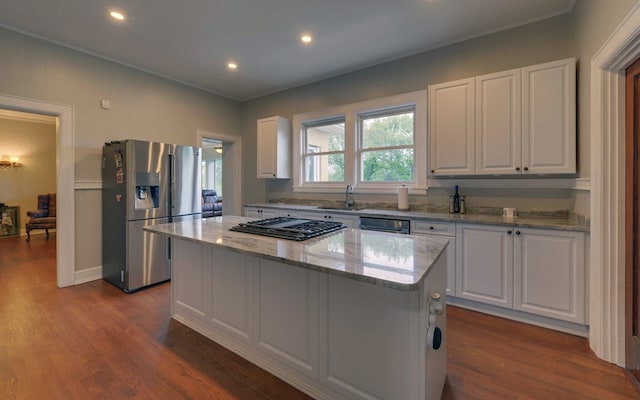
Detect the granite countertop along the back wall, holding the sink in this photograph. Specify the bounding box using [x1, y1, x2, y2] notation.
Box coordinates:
[245, 203, 589, 232]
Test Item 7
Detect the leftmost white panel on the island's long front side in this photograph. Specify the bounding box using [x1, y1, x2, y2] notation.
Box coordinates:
[171, 240, 209, 320]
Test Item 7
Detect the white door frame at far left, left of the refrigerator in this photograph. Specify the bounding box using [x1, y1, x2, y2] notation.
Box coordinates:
[0, 94, 76, 288]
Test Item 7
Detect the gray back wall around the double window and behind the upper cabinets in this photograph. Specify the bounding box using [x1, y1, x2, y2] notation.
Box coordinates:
[242, 15, 588, 209]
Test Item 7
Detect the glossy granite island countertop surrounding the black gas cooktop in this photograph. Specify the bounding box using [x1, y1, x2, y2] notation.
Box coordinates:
[144, 216, 448, 291]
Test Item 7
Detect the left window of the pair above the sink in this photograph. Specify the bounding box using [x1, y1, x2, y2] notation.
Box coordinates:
[302, 120, 345, 182]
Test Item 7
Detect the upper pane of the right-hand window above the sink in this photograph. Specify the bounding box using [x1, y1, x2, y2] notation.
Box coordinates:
[362, 111, 413, 149]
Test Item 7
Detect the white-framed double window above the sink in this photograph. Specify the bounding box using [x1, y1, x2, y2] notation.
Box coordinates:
[293, 90, 427, 193]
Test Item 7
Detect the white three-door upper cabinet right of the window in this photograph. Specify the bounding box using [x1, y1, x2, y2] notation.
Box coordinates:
[429, 59, 576, 176]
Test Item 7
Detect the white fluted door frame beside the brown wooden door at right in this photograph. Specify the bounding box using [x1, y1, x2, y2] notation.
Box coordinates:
[589, 3, 640, 367]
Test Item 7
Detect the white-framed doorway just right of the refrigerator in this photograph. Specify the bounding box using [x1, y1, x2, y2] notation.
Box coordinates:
[197, 130, 242, 215]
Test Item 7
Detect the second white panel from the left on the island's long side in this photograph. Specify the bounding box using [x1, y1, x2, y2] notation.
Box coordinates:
[208, 248, 255, 340]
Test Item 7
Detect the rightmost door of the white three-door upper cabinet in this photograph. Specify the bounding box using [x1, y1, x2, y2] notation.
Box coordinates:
[522, 59, 576, 174]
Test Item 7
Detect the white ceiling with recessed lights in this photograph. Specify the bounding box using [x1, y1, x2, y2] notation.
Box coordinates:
[0, 0, 575, 100]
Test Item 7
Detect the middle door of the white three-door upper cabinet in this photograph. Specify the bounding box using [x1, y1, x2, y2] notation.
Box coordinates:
[475, 69, 522, 174]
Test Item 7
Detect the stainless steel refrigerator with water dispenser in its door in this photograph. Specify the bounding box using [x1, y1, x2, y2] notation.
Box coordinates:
[102, 140, 202, 292]
